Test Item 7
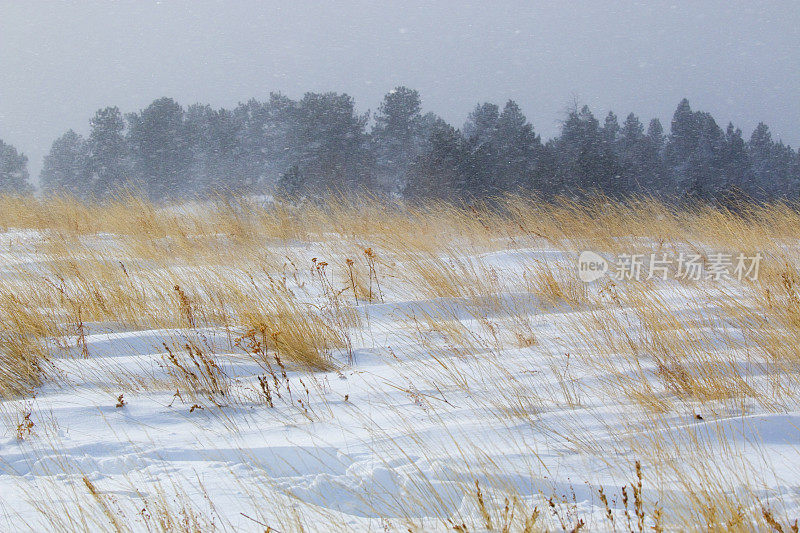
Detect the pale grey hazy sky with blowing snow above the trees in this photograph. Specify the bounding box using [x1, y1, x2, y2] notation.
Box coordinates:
[0, 0, 800, 181]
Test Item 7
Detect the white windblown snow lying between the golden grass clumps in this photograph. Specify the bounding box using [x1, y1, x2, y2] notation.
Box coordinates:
[0, 227, 800, 531]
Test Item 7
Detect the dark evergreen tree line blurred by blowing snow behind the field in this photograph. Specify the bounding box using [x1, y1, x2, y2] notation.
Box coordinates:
[0, 87, 800, 201]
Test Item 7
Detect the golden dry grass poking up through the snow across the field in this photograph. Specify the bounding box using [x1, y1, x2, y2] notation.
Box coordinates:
[0, 195, 800, 531]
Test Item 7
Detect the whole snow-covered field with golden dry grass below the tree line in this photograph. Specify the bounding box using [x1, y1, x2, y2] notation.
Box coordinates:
[0, 195, 800, 532]
